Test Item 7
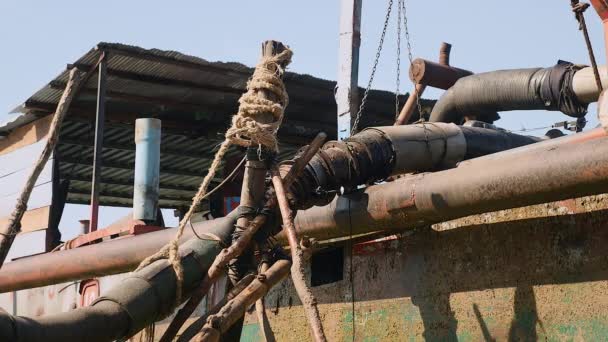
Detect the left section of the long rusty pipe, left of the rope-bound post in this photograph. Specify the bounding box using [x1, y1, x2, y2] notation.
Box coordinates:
[0, 211, 237, 293]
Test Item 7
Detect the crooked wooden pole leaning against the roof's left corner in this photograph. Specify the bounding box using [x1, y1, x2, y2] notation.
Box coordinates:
[0, 69, 86, 267]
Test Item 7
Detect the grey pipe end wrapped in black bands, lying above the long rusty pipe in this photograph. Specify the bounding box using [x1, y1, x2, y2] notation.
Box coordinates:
[290, 123, 540, 208]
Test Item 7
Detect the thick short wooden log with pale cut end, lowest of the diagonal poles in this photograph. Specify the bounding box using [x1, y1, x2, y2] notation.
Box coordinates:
[195, 260, 291, 341]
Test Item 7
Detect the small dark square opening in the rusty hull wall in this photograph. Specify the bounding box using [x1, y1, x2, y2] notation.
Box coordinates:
[310, 247, 344, 286]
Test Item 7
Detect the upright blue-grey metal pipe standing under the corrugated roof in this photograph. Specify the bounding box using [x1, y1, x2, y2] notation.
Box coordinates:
[133, 118, 161, 221]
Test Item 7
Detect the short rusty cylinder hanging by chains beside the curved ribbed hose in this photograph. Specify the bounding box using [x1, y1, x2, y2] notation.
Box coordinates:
[410, 58, 473, 90]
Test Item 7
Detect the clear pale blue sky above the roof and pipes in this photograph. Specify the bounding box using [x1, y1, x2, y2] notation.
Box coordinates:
[0, 0, 605, 231]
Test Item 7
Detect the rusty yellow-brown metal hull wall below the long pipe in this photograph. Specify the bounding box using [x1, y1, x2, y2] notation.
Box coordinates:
[242, 195, 608, 342]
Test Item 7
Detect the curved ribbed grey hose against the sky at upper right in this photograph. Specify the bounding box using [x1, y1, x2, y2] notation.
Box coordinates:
[430, 62, 596, 123]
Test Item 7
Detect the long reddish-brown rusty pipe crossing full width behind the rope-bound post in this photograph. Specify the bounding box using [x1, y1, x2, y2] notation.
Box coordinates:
[0, 131, 608, 292]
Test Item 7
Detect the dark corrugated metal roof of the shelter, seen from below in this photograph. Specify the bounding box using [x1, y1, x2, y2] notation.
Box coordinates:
[0, 43, 434, 207]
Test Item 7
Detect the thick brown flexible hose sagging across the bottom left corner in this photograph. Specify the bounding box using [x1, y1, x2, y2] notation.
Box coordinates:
[0, 219, 232, 342]
